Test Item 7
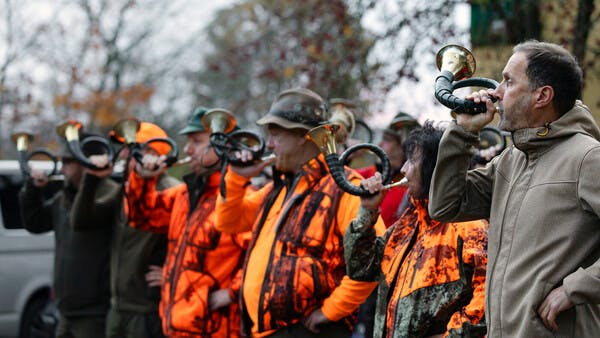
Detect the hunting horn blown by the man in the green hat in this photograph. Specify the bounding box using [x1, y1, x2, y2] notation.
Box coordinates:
[109, 117, 179, 167]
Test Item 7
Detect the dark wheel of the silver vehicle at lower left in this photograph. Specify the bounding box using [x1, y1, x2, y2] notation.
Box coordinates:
[19, 296, 58, 338]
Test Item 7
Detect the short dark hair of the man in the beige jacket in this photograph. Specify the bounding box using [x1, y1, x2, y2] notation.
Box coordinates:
[513, 40, 583, 116]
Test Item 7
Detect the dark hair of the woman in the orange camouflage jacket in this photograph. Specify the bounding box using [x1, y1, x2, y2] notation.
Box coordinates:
[402, 121, 444, 200]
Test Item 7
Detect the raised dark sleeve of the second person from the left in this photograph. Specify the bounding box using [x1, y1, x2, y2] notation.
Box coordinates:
[71, 173, 122, 231]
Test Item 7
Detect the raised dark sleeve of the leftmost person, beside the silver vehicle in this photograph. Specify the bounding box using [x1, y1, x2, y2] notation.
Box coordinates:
[19, 180, 54, 234]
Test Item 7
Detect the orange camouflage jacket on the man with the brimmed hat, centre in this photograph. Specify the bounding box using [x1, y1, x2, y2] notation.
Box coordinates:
[217, 156, 385, 336]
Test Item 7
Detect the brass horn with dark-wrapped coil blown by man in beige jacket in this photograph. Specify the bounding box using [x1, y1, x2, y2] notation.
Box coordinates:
[435, 45, 498, 115]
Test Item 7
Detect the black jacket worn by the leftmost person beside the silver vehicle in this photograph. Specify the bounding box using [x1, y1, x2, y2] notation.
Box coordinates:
[19, 181, 110, 317]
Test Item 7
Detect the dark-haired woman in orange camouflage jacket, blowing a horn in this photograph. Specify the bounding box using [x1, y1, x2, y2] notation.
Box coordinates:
[344, 122, 487, 337]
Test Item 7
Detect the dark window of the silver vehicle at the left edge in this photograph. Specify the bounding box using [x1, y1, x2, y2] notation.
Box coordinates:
[0, 175, 23, 229]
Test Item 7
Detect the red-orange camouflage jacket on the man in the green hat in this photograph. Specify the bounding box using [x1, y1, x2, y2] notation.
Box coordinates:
[127, 173, 250, 337]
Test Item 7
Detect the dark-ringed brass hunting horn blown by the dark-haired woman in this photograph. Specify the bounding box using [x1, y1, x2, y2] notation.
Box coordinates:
[305, 123, 391, 197]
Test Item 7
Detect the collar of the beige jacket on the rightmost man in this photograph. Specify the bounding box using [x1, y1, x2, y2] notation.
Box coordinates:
[512, 100, 600, 153]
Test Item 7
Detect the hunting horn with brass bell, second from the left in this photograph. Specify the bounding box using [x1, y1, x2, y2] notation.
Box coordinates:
[56, 120, 115, 170]
